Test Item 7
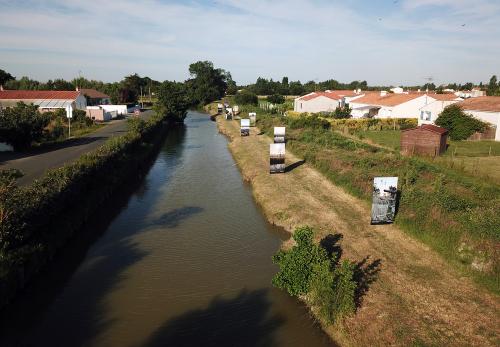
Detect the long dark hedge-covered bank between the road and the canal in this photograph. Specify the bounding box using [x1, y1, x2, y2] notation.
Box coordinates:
[0, 116, 168, 306]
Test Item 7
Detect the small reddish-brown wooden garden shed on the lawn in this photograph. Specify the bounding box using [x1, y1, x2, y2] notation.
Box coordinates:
[401, 124, 448, 156]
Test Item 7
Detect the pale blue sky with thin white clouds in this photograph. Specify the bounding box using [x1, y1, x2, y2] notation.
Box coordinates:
[0, 0, 500, 85]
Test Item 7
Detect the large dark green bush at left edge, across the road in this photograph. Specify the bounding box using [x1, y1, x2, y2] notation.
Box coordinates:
[0, 102, 50, 150]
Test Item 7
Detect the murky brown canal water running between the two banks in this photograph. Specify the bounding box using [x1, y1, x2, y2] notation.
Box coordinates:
[0, 112, 336, 347]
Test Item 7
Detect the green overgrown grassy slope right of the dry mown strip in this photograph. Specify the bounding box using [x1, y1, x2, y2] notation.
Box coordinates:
[250, 110, 500, 292]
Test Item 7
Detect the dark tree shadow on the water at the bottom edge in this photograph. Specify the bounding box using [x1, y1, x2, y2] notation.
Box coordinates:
[144, 289, 284, 347]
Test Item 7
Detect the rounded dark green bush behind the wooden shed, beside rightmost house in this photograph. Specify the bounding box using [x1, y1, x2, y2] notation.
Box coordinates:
[436, 104, 487, 141]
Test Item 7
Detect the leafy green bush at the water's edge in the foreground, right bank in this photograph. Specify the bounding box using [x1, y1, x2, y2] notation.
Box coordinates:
[273, 227, 357, 323]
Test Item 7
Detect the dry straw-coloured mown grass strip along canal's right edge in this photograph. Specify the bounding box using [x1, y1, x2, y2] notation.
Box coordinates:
[217, 117, 500, 346]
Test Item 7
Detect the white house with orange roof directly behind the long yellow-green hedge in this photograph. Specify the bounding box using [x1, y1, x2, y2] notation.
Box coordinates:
[350, 91, 434, 118]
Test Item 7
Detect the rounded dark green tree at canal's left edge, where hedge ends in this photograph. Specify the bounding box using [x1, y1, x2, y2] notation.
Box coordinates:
[154, 81, 190, 122]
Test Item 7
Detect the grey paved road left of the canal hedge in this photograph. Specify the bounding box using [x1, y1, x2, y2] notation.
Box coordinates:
[0, 111, 153, 185]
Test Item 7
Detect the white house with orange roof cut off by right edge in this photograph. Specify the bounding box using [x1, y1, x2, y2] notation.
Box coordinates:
[457, 96, 500, 141]
